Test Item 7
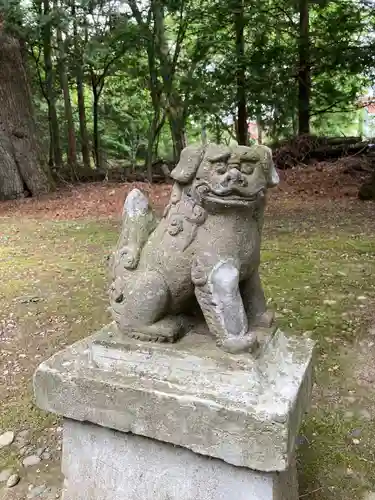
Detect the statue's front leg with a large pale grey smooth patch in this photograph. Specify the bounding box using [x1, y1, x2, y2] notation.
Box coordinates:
[192, 259, 256, 353]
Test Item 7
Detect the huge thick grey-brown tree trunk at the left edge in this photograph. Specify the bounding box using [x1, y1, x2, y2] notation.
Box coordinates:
[0, 28, 50, 199]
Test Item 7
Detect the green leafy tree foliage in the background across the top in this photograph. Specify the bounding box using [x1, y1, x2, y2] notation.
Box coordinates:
[0, 0, 375, 173]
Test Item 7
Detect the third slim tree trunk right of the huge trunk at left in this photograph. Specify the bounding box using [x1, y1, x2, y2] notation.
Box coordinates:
[71, 0, 90, 168]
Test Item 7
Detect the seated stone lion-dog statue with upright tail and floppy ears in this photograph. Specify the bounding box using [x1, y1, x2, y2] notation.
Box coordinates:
[110, 144, 279, 352]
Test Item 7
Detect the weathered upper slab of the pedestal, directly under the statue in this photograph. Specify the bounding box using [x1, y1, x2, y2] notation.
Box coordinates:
[34, 325, 313, 471]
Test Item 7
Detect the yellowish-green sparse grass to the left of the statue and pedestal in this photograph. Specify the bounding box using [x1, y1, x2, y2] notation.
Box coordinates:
[0, 221, 117, 442]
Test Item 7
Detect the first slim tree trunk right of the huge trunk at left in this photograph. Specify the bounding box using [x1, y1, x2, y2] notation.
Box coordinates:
[42, 0, 63, 168]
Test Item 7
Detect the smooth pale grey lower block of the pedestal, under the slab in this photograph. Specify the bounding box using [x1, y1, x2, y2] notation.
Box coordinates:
[62, 419, 298, 500]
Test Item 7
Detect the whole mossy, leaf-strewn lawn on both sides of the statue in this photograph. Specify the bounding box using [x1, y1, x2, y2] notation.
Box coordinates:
[0, 197, 375, 500]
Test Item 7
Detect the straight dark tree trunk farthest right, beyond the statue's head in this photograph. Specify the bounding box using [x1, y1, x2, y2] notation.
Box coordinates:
[298, 0, 311, 135]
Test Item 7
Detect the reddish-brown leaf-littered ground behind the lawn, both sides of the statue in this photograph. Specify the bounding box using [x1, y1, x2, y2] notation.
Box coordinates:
[0, 161, 373, 220]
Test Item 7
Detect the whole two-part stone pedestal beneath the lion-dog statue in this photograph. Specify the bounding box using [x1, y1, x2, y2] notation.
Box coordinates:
[34, 325, 313, 500]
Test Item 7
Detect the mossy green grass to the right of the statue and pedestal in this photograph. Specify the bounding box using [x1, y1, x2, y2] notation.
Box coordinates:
[262, 230, 375, 500]
